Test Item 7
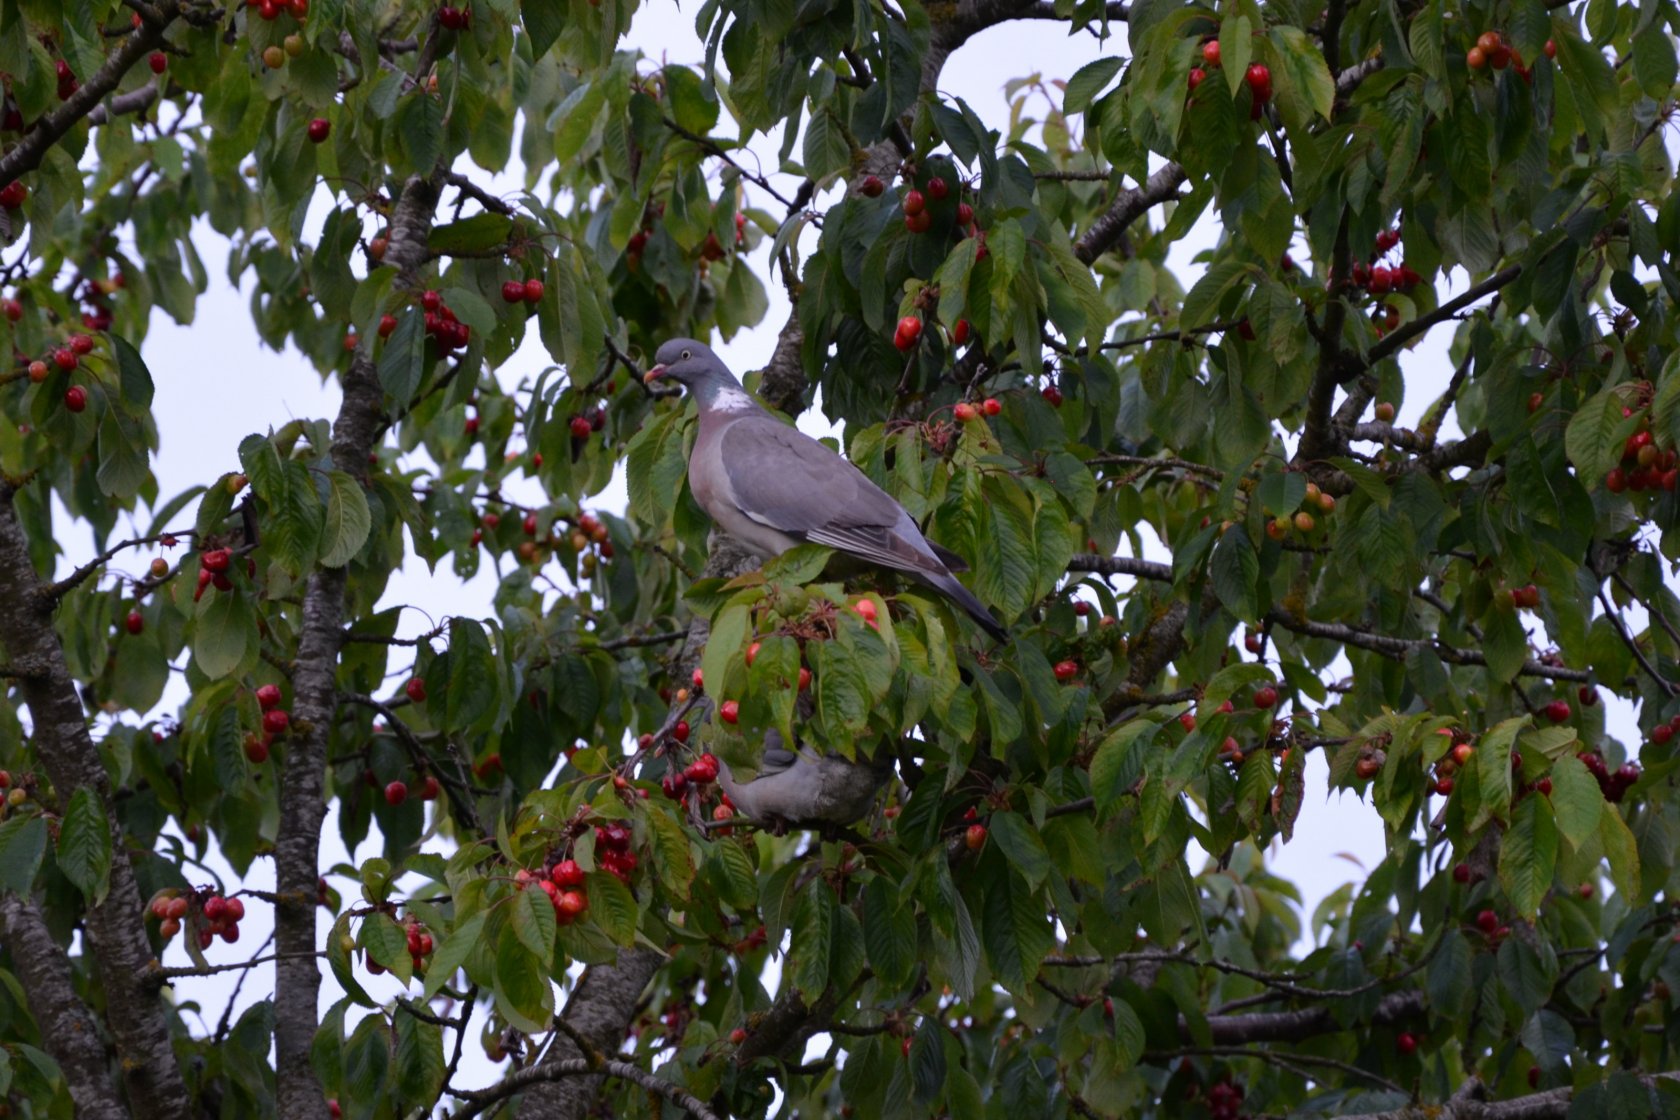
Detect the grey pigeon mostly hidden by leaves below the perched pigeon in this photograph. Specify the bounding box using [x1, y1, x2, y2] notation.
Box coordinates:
[717, 727, 892, 826]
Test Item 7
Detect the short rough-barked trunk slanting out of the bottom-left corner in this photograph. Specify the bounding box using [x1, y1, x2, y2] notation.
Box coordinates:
[0, 895, 128, 1120]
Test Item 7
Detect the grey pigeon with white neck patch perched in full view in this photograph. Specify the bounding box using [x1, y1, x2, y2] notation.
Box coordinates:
[643, 338, 1010, 641]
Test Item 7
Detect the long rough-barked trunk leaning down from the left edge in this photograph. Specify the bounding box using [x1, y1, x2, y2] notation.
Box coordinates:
[0, 484, 188, 1120]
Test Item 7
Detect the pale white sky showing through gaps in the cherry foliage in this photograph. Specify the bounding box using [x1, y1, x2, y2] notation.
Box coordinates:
[39, 0, 1653, 1086]
